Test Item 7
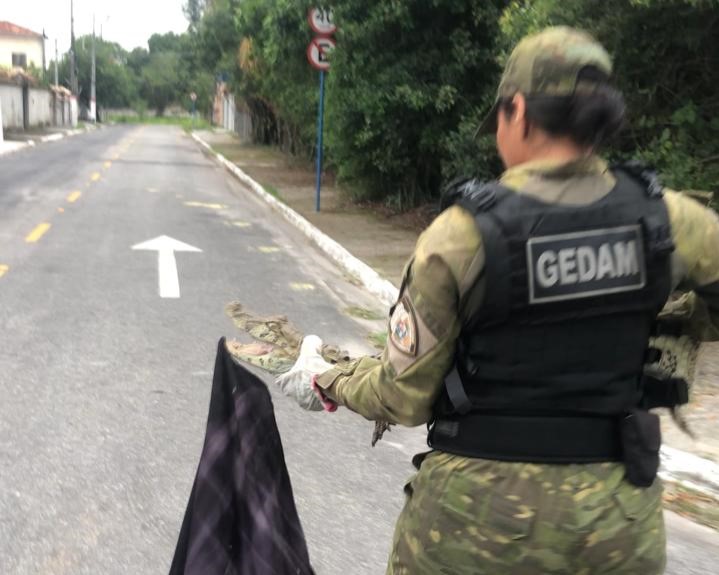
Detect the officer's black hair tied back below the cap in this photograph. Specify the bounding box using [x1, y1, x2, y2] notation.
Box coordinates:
[500, 66, 626, 148]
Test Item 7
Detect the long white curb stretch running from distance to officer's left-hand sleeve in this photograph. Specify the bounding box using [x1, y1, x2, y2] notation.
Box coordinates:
[192, 132, 399, 306]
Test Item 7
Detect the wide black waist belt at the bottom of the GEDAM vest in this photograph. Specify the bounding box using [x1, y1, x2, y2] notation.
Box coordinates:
[428, 413, 622, 463]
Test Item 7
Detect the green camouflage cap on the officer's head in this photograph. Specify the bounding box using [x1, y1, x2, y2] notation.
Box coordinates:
[477, 26, 612, 134]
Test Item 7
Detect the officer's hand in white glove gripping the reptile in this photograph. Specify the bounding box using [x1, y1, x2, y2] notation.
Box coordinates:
[275, 335, 337, 411]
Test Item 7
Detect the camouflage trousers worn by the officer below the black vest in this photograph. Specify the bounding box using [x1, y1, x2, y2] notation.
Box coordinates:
[387, 452, 666, 575]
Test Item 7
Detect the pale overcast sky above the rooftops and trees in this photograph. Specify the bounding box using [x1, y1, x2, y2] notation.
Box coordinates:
[0, 0, 187, 56]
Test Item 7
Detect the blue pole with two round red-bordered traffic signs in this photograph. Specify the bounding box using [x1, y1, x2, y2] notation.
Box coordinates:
[307, 8, 337, 212]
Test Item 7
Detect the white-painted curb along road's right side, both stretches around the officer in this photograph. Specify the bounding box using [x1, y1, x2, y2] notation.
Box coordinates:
[192, 132, 719, 501]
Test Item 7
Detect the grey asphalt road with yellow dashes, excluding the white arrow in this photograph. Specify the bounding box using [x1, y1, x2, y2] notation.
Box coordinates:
[0, 127, 719, 575]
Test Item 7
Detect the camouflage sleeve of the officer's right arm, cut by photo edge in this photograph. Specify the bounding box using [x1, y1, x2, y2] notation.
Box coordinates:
[664, 190, 719, 341]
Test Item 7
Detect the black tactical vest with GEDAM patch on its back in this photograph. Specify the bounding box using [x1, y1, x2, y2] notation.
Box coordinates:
[429, 167, 674, 462]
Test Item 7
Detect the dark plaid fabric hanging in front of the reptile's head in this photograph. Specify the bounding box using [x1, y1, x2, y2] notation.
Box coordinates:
[170, 338, 313, 575]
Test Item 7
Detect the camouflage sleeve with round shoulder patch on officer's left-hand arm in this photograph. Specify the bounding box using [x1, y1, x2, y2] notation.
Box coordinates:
[318, 207, 484, 426]
